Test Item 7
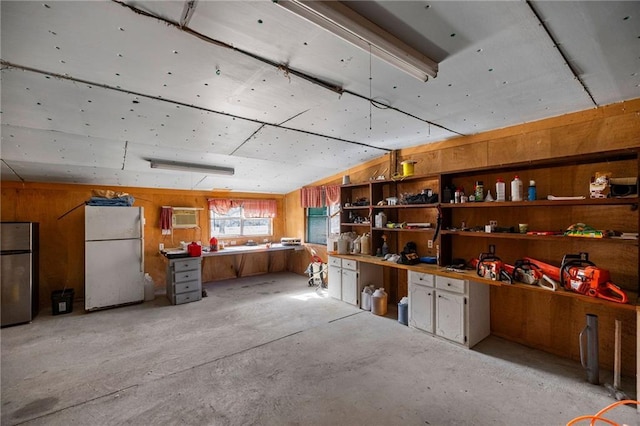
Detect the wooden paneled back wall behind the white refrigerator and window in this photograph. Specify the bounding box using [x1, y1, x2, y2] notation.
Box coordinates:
[1, 182, 288, 307]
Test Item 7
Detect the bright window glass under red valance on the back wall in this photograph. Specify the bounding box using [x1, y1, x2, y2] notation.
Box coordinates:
[209, 206, 273, 237]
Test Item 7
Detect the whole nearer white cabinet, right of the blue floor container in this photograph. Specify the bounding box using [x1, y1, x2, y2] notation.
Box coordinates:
[408, 271, 491, 348]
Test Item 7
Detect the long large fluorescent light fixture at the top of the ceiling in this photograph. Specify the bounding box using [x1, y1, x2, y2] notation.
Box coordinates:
[273, 0, 438, 81]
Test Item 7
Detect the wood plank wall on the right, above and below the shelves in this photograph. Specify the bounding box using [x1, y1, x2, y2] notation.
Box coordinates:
[286, 99, 640, 375]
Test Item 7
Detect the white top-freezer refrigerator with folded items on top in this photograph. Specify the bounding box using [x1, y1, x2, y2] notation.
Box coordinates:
[84, 206, 144, 311]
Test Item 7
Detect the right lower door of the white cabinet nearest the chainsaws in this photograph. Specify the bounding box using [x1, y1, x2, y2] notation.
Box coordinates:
[435, 291, 466, 344]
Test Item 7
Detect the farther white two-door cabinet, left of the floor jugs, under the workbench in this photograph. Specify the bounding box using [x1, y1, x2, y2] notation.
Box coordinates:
[328, 256, 382, 306]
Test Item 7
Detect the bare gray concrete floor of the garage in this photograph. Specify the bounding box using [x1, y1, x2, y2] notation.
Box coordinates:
[1, 273, 639, 425]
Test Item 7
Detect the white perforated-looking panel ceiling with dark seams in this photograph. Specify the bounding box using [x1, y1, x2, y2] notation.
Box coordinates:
[0, 0, 640, 194]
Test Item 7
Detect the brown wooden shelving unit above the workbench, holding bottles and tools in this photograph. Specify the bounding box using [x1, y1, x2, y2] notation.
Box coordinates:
[341, 149, 640, 296]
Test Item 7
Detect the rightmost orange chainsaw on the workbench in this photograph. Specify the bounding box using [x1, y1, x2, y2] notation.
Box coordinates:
[560, 252, 628, 303]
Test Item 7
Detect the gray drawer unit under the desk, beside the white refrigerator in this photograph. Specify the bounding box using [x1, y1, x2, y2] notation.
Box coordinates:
[167, 257, 202, 305]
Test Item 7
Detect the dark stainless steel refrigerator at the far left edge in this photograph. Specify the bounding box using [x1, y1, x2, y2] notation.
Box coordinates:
[0, 222, 39, 327]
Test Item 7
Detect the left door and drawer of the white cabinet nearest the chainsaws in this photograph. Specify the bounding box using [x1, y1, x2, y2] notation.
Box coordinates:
[409, 271, 435, 333]
